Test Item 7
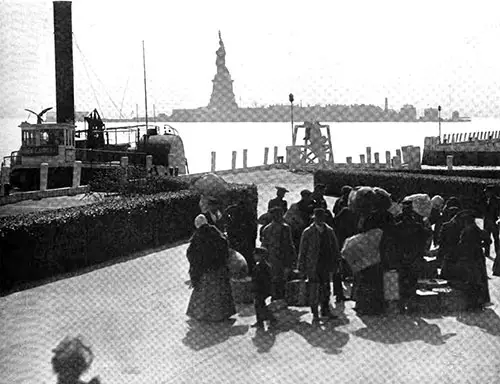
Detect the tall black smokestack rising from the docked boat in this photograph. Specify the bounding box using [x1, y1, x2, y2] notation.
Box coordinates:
[54, 1, 75, 124]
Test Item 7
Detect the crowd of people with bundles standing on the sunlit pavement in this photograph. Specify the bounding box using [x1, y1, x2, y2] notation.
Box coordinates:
[187, 184, 500, 327]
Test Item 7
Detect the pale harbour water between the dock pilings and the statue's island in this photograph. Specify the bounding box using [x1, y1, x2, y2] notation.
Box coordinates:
[0, 118, 500, 173]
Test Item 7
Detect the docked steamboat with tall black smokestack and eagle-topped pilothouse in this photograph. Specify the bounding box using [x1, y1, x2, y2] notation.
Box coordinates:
[2, 1, 187, 190]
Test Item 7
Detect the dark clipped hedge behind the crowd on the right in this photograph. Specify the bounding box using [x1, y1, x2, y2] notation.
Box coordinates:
[314, 170, 500, 209]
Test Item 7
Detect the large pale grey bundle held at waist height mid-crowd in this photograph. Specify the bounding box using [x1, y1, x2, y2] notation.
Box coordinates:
[342, 228, 382, 273]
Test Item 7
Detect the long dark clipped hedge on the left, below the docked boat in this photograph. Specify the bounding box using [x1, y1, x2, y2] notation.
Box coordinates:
[0, 185, 257, 291]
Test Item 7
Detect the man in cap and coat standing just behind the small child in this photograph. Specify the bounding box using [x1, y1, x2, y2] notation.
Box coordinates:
[261, 207, 297, 300]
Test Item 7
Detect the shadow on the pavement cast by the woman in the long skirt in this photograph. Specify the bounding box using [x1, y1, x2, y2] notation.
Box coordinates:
[182, 319, 248, 351]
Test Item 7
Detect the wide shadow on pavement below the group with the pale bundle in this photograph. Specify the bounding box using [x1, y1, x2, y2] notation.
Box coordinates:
[354, 315, 456, 345]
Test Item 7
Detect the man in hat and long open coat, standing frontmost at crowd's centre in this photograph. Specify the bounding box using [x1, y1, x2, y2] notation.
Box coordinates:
[298, 208, 340, 322]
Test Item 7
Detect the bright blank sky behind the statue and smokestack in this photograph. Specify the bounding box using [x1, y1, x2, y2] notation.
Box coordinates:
[0, 0, 500, 117]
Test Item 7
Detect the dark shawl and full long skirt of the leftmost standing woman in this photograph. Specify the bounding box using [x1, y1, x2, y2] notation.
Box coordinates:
[186, 224, 236, 321]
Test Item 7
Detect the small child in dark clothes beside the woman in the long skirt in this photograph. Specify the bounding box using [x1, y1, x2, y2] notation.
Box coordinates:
[252, 248, 277, 328]
